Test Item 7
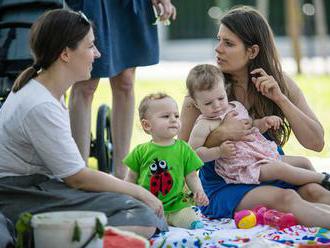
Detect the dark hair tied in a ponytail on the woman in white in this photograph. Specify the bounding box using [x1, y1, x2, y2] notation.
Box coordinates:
[12, 9, 91, 92]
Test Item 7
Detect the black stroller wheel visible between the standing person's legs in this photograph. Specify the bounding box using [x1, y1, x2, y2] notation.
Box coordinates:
[95, 104, 114, 174]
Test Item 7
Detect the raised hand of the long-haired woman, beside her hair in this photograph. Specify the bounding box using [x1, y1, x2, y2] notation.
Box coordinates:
[250, 68, 285, 103]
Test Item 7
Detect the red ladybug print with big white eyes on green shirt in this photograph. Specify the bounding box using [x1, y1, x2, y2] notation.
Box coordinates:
[149, 158, 173, 196]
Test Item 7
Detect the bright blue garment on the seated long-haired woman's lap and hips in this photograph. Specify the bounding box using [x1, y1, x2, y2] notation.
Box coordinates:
[199, 161, 298, 218]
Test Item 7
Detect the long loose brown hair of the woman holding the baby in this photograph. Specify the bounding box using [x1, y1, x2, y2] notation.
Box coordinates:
[221, 6, 291, 146]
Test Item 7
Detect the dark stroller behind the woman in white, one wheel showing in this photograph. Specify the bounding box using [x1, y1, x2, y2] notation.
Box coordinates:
[0, 0, 114, 173]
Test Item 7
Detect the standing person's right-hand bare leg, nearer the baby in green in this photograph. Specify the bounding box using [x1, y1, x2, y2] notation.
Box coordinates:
[110, 68, 135, 179]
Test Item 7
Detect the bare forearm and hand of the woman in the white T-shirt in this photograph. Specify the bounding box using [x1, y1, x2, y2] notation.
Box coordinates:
[63, 167, 163, 216]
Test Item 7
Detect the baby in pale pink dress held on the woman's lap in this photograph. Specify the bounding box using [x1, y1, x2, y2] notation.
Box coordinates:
[187, 64, 330, 189]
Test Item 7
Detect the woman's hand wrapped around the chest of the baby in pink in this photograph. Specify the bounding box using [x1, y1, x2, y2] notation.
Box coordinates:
[205, 111, 254, 147]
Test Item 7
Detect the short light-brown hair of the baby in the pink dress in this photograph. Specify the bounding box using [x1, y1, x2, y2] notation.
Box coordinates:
[186, 64, 224, 99]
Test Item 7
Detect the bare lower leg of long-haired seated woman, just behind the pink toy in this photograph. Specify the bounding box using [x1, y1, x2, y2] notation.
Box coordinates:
[236, 186, 330, 228]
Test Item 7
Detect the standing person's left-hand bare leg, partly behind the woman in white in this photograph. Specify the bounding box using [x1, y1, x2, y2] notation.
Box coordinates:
[69, 79, 99, 165]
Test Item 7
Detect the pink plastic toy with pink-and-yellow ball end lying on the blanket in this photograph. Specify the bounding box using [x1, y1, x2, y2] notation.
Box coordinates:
[234, 206, 297, 229]
